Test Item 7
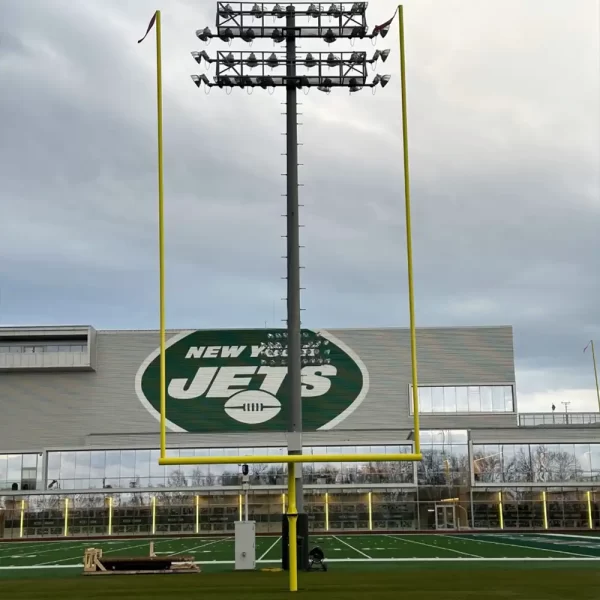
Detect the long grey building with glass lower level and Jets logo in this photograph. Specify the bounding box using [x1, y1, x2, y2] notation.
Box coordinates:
[0, 326, 600, 538]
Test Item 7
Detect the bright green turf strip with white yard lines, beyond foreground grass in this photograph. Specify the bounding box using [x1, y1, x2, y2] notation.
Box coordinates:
[0, 533, 600, 576]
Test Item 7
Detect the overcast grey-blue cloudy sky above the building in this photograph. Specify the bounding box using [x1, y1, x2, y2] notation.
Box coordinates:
[0, 0, 600, 410]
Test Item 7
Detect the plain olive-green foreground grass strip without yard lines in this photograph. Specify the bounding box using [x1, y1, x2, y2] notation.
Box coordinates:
[1, 568, 600, 600]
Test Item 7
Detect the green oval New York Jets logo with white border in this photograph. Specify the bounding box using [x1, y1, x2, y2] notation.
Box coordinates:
[135, 329, 369, 433]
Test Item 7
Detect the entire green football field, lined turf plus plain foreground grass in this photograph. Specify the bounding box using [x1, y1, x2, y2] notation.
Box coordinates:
[0, 533, 600, 600]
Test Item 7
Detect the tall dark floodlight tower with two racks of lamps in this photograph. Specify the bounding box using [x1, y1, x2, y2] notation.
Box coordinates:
[192, 2, 393, 576]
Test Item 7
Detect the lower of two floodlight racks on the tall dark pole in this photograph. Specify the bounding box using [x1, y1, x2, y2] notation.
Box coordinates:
[192, 50, 390, 92]
